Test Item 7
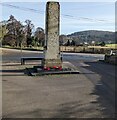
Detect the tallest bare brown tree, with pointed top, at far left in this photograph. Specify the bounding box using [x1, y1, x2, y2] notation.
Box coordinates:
[3, 15, 23, 47]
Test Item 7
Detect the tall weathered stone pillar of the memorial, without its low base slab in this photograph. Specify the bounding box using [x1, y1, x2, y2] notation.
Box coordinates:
[42, 1, 62, 68]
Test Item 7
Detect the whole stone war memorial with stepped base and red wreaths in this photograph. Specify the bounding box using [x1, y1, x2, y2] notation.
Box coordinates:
[26, 1, 79, 75]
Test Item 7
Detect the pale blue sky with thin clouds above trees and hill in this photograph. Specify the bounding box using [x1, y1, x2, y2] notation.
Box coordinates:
[0, 2, 115, 34]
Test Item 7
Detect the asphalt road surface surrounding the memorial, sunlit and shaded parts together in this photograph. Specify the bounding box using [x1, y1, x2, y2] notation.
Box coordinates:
[2, 50, 116, 118]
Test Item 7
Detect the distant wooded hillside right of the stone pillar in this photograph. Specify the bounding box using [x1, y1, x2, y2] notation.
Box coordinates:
[67, 30, 115, 44]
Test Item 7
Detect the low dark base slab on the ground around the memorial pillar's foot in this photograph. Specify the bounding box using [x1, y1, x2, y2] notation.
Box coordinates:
[25, 63, 80, 76]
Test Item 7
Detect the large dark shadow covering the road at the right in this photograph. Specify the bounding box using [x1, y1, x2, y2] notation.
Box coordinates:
[83, 61, 117, 118]
